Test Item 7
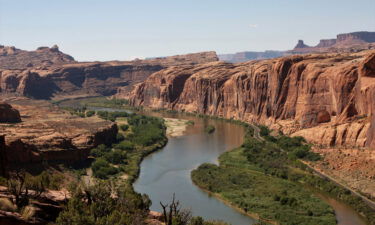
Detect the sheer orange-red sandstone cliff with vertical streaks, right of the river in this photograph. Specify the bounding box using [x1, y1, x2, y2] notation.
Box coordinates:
[128, 51, 375, 147]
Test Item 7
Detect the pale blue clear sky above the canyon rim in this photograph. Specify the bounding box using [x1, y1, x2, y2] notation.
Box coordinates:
[0, 0, 375, 61]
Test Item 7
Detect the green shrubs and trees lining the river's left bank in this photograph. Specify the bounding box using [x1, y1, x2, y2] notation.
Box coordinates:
[51, 108, 225, 225]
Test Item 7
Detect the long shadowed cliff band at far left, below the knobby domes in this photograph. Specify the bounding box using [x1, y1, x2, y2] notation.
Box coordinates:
[0, 51, 218, 99]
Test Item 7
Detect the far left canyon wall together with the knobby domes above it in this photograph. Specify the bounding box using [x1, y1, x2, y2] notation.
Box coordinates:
[0, 46, 218, 99]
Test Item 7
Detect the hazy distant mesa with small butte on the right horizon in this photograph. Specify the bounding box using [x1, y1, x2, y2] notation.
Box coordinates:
[218, 31, 375, 63]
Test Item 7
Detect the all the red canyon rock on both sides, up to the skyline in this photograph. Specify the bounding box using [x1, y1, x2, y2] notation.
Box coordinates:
[0, 32, 375, 199]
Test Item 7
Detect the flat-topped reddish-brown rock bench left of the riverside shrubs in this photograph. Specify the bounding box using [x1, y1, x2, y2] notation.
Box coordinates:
[0, 98, 117, 172]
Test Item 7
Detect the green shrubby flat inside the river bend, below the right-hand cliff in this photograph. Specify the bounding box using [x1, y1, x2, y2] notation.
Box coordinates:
[192, 127, 375, 225]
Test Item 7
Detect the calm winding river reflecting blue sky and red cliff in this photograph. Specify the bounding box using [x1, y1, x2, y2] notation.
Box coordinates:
[58, 99, 366, 225]
